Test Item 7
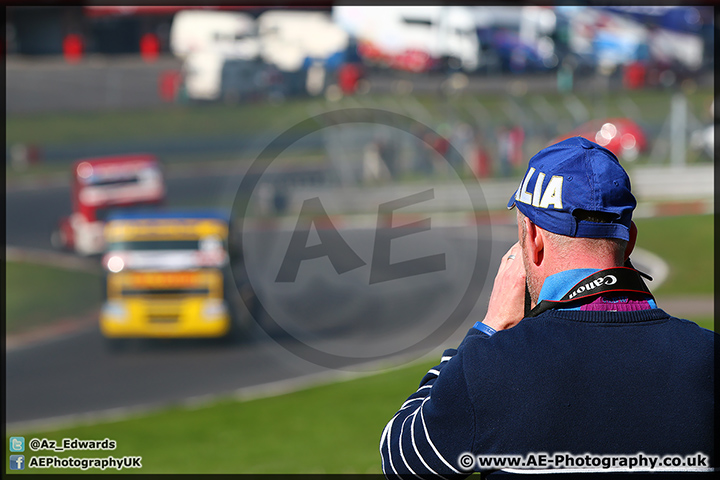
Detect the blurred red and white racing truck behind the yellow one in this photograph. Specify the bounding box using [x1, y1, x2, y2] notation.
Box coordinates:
[50, 154, 165, 255]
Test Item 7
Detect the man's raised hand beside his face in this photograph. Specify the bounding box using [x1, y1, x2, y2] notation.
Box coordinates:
[483, 243, 525, 331]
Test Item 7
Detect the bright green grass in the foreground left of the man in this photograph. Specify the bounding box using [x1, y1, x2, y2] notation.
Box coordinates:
[6, 360, 437, 474]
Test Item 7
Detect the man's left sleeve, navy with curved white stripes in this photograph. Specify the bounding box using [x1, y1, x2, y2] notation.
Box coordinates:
[380, 349, 475, 479]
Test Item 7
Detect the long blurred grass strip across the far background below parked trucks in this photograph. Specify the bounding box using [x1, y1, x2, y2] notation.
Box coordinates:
[5, 88, 713, 146]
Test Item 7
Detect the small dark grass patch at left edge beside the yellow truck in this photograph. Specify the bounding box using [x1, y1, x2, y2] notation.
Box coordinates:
[5, 262, 102, 333]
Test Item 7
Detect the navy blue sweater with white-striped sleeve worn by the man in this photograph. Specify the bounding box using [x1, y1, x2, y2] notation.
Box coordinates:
[380, 270, 716, 478]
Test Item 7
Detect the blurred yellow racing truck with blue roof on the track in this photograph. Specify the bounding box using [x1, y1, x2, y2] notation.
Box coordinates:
[100, 212, 249, 349]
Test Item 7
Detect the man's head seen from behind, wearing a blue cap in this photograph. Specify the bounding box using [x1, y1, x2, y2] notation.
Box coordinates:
[508, 137, 637, 304]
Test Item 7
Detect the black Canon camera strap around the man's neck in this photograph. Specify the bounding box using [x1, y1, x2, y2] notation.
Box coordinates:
[526, 262, 654, 317]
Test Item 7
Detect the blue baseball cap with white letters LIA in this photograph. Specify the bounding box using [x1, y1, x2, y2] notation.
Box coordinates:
[508, 137, 637, 240]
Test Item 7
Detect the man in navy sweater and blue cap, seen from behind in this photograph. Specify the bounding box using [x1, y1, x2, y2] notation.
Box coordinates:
[380, 137, 715, 478]
